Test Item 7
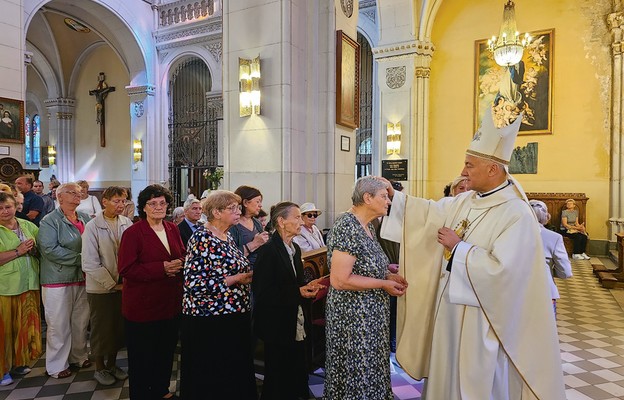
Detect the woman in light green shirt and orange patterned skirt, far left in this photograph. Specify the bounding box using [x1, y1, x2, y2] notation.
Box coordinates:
[0, 192, 41, 386]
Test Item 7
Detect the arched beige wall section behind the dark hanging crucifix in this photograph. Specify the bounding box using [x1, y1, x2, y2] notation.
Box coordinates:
[74, 46, 132, 188]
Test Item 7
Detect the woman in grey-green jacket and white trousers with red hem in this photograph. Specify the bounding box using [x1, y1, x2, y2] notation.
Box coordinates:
[39, 183, 91, 379]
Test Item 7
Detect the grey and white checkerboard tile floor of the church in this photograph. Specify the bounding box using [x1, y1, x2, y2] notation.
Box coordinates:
[0, 259, 624, 400]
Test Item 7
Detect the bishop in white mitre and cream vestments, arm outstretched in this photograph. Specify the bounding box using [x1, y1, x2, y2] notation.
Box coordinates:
[381, 110, 565, 400]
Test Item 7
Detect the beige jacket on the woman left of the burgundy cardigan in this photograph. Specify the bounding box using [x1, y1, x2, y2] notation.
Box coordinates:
[82, 211, 132, 293]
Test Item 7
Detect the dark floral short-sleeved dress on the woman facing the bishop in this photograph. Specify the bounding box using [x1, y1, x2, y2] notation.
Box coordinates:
[323, 213, 394, 400]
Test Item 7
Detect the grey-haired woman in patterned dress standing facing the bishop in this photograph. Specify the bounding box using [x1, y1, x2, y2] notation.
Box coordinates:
[324, 176, 407, 400]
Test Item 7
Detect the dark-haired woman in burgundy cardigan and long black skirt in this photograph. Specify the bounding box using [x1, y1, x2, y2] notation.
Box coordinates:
[118, 185, 184, 399]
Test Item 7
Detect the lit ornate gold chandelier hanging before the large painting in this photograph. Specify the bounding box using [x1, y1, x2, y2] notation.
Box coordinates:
[488, 0, 531, 67]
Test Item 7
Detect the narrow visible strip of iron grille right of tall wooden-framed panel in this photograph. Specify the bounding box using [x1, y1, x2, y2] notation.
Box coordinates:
[355, 32, 373, 178]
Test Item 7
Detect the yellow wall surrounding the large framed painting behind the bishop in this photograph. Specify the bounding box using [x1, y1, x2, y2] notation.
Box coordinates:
[427, 0, 611, 240]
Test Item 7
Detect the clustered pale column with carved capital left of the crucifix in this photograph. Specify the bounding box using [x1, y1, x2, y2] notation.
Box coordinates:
[44, 97, 76, 183]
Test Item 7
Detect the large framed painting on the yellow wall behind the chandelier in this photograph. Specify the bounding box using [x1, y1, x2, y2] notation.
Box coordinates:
[474, 29, 555, 135]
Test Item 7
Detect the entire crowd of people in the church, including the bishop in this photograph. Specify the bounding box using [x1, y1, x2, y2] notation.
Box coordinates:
[0, 108, 576, 400]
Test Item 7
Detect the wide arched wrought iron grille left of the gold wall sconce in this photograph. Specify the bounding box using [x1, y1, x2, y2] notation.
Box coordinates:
[169, 58, 223, 204]
